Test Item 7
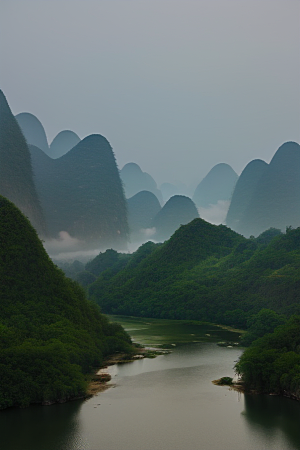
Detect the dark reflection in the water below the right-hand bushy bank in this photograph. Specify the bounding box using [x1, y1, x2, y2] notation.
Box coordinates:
[242, 394, 300, 449]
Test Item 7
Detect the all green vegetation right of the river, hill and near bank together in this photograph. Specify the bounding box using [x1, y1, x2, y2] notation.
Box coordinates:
[82, 219, 300, 399]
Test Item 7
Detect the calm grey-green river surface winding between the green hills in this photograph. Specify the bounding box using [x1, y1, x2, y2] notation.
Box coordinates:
[0, 319, 300, 450]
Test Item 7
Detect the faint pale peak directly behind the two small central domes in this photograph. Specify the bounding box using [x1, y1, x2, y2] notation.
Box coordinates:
[120, 163, 163, 203]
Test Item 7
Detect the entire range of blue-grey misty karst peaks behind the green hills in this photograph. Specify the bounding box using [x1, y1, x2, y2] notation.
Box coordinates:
[0, 88, 300, 256]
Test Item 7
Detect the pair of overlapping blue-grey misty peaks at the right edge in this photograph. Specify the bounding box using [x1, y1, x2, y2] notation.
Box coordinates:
[226, 142, 300, 237]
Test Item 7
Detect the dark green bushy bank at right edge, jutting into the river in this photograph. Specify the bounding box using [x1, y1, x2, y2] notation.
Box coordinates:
[235, 316, 300, 400]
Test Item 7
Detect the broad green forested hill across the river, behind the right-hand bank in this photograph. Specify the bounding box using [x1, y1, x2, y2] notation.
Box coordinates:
[85, 219, 300, 328]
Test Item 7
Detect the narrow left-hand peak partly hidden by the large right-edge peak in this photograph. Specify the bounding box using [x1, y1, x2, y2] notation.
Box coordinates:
[226, 159, 268, 232]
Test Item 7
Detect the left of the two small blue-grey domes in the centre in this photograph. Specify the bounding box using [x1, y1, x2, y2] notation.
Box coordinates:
[127, 191, 161, 240]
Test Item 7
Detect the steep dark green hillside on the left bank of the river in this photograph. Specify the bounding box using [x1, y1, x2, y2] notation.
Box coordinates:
[0, 197, 131, 409]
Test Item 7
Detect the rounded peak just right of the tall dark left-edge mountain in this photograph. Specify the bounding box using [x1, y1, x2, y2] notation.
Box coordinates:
[16, 112, 49, 154]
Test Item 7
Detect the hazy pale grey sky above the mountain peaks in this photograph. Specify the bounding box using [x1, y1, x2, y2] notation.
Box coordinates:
[0, 0, 300, 184]
